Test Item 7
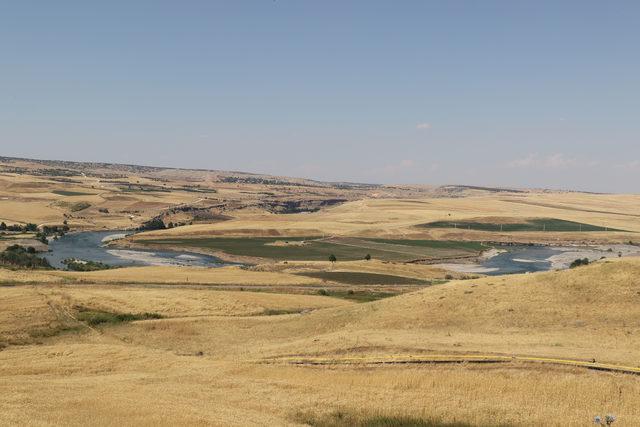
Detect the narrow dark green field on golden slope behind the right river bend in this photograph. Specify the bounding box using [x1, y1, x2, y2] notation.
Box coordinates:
[420, 218, 624, 232]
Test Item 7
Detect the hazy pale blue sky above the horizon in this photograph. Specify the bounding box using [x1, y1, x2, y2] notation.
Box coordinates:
[0, 0, 640, 192]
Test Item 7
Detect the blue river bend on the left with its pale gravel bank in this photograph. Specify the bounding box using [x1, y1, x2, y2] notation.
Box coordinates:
[44, 231, 229, 268]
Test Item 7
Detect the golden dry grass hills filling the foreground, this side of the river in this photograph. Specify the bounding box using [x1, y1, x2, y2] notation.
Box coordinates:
[0, 259, 640, 425]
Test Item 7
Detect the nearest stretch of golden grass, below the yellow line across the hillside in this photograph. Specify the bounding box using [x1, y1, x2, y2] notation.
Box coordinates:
[0, 343, 640, 426]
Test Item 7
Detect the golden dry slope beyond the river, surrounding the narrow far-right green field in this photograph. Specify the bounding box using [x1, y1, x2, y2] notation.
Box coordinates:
[137, 193, 640, 241]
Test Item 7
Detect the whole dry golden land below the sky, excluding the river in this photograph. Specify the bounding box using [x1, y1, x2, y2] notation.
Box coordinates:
[0, 158, 640, 426]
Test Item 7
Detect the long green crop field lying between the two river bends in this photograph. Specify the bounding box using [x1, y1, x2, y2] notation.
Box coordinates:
[138, 237, 486, 262]
